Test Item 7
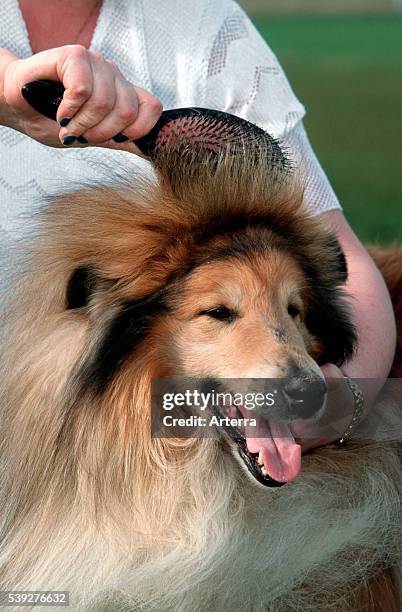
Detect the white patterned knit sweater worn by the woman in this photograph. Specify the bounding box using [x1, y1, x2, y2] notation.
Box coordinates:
[0, 0, 339, 286]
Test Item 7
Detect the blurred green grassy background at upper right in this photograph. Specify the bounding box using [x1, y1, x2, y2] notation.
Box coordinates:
[239, 0, 402, 244]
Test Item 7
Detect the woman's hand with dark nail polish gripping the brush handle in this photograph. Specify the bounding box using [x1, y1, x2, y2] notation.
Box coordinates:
[0, 45, 162, 155]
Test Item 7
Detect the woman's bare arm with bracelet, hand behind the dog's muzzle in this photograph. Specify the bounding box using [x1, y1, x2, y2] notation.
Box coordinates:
[297, 210, 396, 451]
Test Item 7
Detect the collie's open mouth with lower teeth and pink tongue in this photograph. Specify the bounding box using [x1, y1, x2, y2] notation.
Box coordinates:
[218, 407, 301, 487]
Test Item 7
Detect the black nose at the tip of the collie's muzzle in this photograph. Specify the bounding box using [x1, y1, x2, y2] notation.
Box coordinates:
[282, 371, 327, 419]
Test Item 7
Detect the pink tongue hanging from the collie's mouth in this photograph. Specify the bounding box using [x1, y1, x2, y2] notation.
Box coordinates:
[240, 407, 301, 482]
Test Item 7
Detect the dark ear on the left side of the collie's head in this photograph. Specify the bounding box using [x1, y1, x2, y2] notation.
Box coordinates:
[66, 265, 111, 310]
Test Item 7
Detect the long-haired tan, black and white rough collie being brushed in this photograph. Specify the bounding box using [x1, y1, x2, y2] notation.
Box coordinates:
[0, 135, 402, 612]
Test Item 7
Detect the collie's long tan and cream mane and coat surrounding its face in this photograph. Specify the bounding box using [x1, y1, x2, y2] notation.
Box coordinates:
[0, 142, 401, 612]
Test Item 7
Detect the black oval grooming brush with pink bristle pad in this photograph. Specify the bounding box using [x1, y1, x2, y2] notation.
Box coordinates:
[21, 80, 288, 172]
